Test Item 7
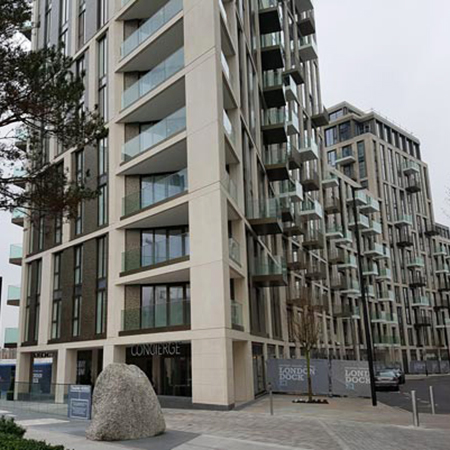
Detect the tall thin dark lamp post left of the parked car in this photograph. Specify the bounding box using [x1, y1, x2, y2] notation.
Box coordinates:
[352, 186, 377, 406]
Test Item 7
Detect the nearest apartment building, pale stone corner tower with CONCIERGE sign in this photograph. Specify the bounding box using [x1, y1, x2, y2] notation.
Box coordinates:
[11, 0, 335, 408]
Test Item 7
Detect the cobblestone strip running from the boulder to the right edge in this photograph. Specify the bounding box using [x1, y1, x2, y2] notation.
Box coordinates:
[166, 410, 450, 450]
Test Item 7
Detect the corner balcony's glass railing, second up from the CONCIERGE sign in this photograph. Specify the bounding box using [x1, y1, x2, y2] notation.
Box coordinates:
[122, 233, 189, 272]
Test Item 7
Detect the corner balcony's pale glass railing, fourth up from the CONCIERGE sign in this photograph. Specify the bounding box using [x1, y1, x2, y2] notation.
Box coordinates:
[122, 108, 186, 161]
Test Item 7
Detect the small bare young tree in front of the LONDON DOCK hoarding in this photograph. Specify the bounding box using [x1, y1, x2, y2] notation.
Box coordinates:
[292, 289, 322, 402]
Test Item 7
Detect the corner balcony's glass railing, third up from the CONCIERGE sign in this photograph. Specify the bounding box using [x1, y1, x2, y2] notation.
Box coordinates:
[122, 169, 188, 216]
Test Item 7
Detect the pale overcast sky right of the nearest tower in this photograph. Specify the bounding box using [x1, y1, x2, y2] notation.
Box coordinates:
[315, 0, 450, 225]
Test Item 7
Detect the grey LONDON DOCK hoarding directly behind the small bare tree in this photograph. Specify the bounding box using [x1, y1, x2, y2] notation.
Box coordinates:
[267, 359, 330, 395]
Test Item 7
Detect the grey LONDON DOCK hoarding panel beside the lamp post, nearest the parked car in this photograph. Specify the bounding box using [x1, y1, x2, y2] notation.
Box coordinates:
[331, 360, 370, 397]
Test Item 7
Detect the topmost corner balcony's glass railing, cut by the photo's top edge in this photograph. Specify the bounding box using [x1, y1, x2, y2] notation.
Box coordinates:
[121, 0, 183, 58]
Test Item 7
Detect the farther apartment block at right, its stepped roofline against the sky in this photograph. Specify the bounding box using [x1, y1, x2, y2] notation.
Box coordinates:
[325, 103, 450, 367]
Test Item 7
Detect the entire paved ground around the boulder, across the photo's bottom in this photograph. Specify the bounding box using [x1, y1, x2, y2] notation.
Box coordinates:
[0, 395, 450, 450]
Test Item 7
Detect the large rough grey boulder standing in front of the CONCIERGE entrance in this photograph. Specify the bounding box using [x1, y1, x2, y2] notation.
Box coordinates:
[86, 364, 166, 441]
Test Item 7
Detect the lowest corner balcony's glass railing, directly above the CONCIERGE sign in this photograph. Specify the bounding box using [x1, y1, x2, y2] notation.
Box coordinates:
[121, 300, 191, 334]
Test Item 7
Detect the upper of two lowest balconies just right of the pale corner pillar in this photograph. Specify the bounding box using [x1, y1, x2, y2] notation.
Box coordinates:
[248, 198, 283, 236]
